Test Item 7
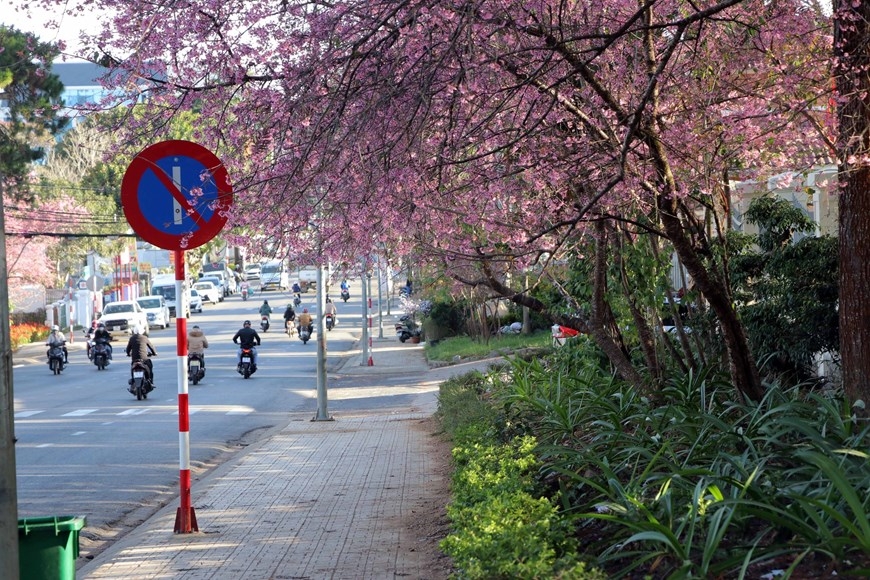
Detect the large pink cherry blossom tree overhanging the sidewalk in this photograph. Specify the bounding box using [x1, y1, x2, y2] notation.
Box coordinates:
[29, 0, 835, 399]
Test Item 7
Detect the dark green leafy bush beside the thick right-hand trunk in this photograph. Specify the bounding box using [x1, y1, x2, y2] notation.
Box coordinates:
[730, 197, 840, 380]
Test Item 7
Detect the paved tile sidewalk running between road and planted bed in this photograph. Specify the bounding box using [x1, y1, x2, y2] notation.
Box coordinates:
[76, 337, 504, 580]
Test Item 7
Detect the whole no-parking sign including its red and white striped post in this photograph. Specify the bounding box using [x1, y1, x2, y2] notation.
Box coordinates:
[121, 141, 233, 534]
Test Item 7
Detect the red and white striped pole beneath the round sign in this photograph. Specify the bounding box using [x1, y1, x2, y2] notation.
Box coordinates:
[175, 250, 199, 534]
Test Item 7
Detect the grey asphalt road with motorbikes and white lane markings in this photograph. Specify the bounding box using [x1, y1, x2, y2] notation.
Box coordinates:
[14, 284, 362, 551]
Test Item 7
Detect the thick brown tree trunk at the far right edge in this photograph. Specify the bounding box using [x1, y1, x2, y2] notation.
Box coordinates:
[834, 2, 870, 402]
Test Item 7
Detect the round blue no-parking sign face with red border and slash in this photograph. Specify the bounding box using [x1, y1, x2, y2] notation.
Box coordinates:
[121, 140, 233, 250]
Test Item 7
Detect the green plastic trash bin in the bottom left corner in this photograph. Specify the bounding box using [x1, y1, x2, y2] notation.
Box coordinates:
[18, 516, 86, 580]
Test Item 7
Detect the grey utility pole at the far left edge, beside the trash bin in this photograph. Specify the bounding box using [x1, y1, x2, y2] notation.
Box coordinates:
[0, 184, 18, 580]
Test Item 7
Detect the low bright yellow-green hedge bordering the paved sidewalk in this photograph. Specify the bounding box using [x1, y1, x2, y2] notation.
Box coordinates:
[439, 373, 604, 580]
